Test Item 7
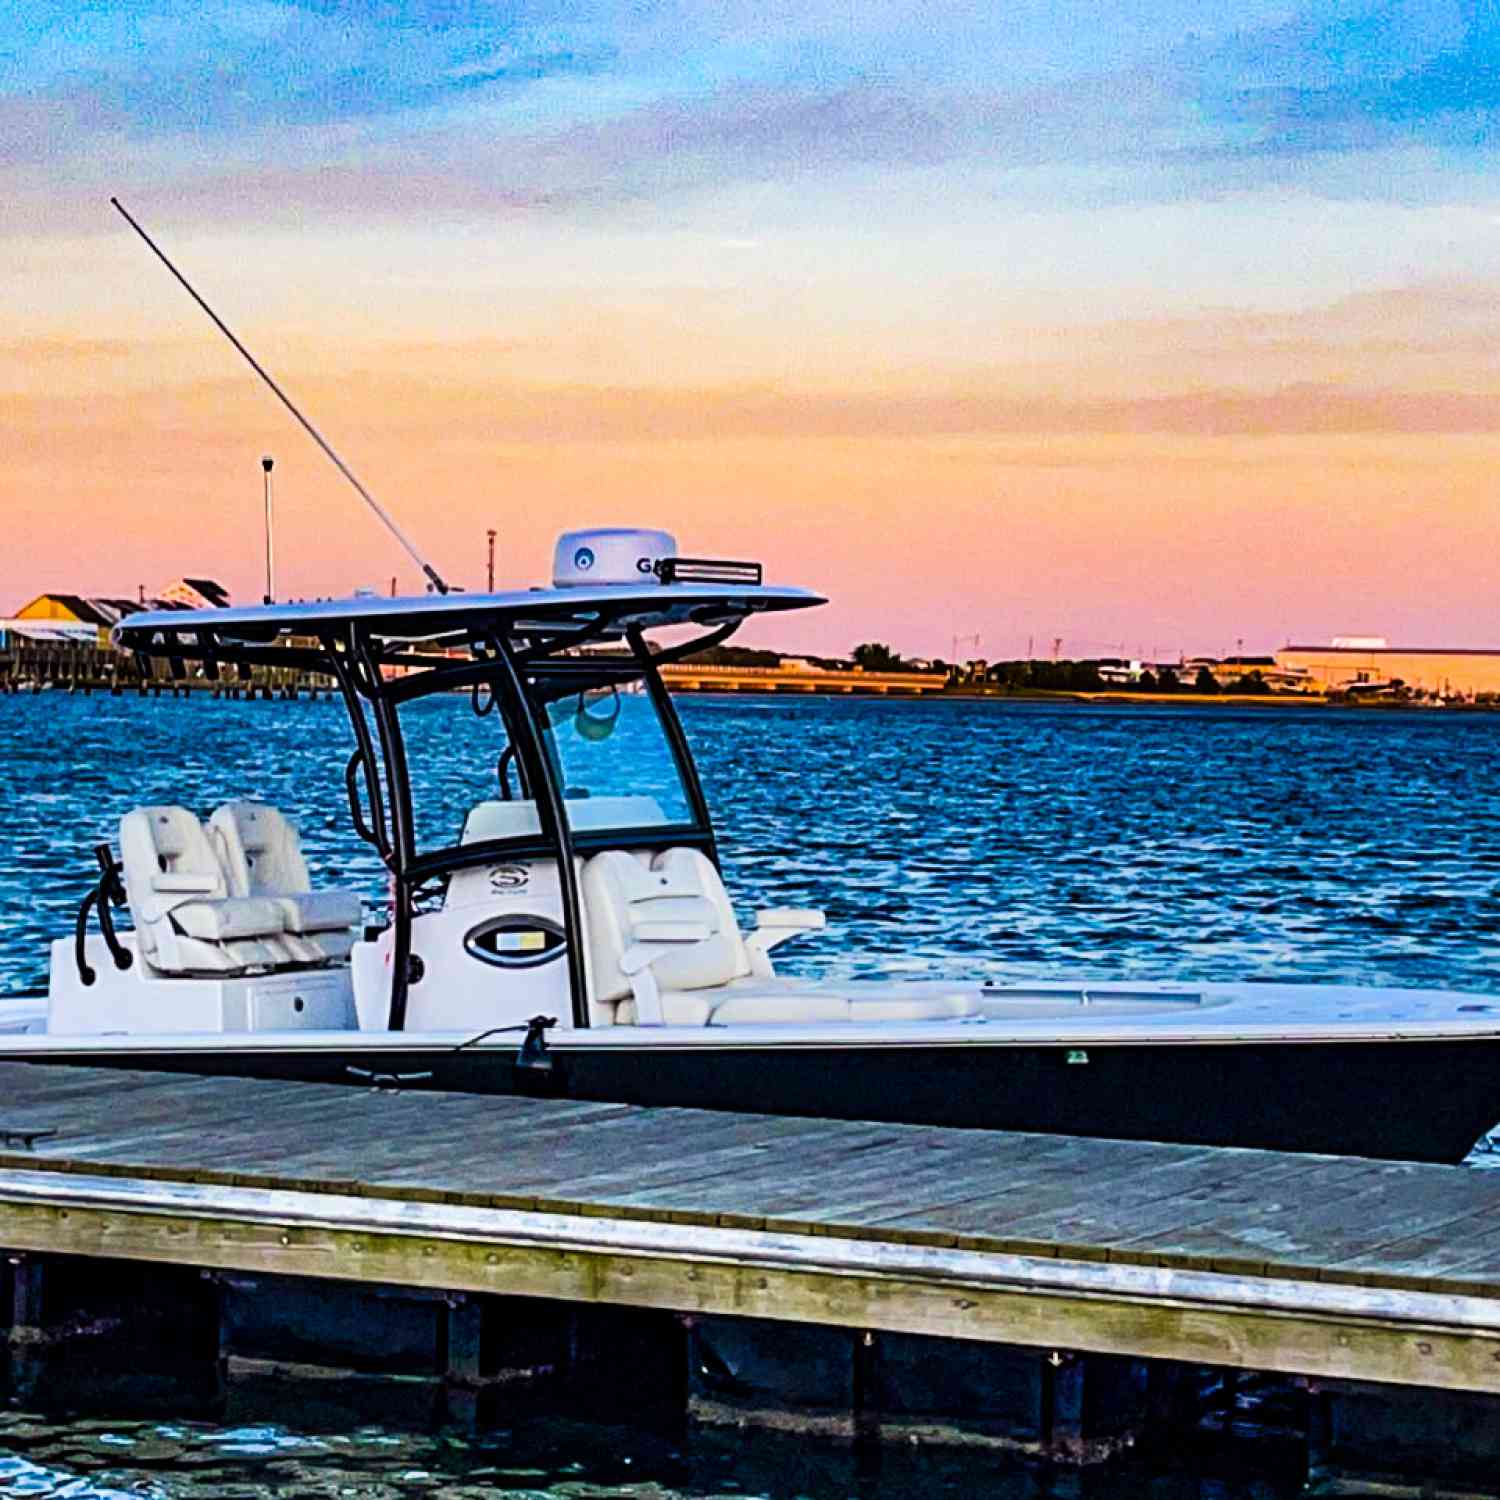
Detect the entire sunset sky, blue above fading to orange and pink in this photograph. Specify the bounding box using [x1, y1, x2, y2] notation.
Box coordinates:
[0, 0, 1500, 659]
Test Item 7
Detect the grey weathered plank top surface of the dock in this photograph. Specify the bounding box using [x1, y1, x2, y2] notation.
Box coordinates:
[0, 1064, 1500, 1295]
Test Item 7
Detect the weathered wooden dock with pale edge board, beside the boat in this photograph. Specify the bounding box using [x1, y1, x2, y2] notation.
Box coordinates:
[0, 1064, 1500, 1394]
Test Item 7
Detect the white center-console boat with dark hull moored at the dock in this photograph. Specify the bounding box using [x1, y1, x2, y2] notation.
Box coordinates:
[0, 528, 1500, 1163]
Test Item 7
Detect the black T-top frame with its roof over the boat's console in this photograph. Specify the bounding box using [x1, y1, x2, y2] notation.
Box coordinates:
[116, 585, 804, 1031]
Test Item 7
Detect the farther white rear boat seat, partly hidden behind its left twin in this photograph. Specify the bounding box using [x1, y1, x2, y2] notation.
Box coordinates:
[209, 803, 365, 959]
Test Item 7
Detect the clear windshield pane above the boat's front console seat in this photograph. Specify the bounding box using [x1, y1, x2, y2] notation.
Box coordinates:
[528, 674, 693, 833]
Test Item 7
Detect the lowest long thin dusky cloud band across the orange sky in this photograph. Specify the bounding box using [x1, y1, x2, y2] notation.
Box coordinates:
[12, 368, 1500, 438]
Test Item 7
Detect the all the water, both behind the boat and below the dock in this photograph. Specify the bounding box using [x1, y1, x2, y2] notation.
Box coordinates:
[0, 693, 1500, 1500]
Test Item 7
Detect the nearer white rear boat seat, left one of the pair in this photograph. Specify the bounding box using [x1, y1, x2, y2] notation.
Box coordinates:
[120, 807, 297, 974]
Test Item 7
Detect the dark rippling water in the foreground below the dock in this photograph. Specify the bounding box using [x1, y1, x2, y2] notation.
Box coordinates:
[0, 1413, 1299, 1500]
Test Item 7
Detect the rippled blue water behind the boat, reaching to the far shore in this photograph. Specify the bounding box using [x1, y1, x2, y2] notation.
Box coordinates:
[0, 693, 1500, 990]
